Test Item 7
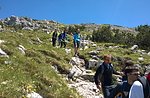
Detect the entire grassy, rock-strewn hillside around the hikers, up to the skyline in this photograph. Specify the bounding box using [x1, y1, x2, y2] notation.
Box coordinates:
[0, 16, 150, 98]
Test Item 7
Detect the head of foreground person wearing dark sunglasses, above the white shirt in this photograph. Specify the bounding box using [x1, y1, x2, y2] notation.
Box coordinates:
[125, 64, 140, 83]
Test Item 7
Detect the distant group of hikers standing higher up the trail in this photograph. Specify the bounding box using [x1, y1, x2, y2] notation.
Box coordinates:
[52, 29, 80, 56]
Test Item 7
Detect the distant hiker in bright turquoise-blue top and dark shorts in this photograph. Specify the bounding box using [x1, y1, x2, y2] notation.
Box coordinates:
[73, 29, 80, 56]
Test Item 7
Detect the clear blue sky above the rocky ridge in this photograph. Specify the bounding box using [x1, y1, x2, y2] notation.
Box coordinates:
[0, 0, 150, 27]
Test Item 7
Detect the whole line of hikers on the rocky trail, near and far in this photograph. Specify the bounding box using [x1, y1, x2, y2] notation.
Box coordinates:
[52, 29, 150, 98]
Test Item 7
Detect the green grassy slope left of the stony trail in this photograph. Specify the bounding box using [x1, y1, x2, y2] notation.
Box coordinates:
[0, 31, 80, 98]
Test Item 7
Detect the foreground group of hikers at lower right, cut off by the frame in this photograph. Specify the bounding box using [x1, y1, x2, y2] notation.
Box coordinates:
[94, 55, 150, 98]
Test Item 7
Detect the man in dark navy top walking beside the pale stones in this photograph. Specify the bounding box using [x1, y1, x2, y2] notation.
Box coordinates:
[94, 55, 123, 98]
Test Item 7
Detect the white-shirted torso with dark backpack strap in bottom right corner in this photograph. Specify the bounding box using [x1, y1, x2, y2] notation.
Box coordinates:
[129, 66, 150, 98]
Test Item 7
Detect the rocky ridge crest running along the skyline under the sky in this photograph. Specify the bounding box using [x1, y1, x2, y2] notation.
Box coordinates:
[0, 16, 138, 34]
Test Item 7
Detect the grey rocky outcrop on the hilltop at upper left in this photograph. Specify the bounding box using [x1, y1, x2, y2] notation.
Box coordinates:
[0, 15, 61, 32]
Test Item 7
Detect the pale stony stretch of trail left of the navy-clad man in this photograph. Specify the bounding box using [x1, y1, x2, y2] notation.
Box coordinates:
[68, 57, 103, 98]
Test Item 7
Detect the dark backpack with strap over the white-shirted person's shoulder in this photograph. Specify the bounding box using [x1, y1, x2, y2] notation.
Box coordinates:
[138, 76, 150, 98]
